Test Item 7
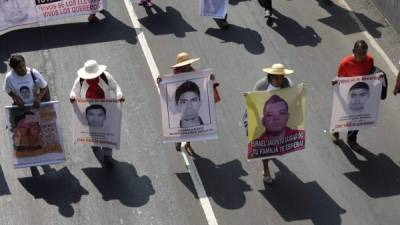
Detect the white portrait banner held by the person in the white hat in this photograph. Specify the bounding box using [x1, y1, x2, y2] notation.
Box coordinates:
[73, 99, 122, 149]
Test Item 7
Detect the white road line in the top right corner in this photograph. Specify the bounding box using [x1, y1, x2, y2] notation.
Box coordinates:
[340, 0, 399, 76]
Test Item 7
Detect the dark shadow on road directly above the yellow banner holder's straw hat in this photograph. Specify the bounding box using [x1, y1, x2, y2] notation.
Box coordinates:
[271, 9, 322, 47]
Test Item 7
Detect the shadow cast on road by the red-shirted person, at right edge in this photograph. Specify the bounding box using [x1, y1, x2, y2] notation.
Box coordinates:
[338, 141, 400, 198]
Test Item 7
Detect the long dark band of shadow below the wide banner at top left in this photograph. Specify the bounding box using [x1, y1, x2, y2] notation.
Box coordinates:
[0, 11, 137, 73]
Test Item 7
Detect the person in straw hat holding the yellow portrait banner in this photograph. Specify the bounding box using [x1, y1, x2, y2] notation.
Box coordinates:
[243, 63, 294, 184]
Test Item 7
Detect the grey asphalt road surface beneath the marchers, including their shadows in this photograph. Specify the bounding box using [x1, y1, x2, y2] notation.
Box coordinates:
[0, 0, 400, 225]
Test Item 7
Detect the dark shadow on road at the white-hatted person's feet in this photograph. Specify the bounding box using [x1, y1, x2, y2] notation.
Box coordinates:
[82, 160, 155, 207]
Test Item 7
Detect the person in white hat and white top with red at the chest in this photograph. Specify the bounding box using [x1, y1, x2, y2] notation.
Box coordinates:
[70, 60, 125, 166]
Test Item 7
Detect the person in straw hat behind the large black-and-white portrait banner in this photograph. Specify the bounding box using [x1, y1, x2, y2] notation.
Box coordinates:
[157, 52, 220, 156]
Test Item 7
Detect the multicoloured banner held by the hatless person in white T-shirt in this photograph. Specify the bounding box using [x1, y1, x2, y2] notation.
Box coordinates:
[5, 101, 65, 168]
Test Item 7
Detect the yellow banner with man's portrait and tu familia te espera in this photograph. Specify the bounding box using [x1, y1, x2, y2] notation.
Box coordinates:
[245, 84, 306, 159]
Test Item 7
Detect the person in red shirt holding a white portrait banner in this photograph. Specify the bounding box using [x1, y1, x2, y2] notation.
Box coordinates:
[332, 40, 374, 152]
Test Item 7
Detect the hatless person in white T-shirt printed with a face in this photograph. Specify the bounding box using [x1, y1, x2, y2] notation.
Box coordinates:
[3, 55, 50, 107]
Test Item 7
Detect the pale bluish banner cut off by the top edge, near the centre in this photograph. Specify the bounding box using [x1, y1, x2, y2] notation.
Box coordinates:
[199, 0, 228, 19]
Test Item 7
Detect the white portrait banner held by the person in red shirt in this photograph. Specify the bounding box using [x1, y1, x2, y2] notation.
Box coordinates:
[330, 73, 382, 132]
